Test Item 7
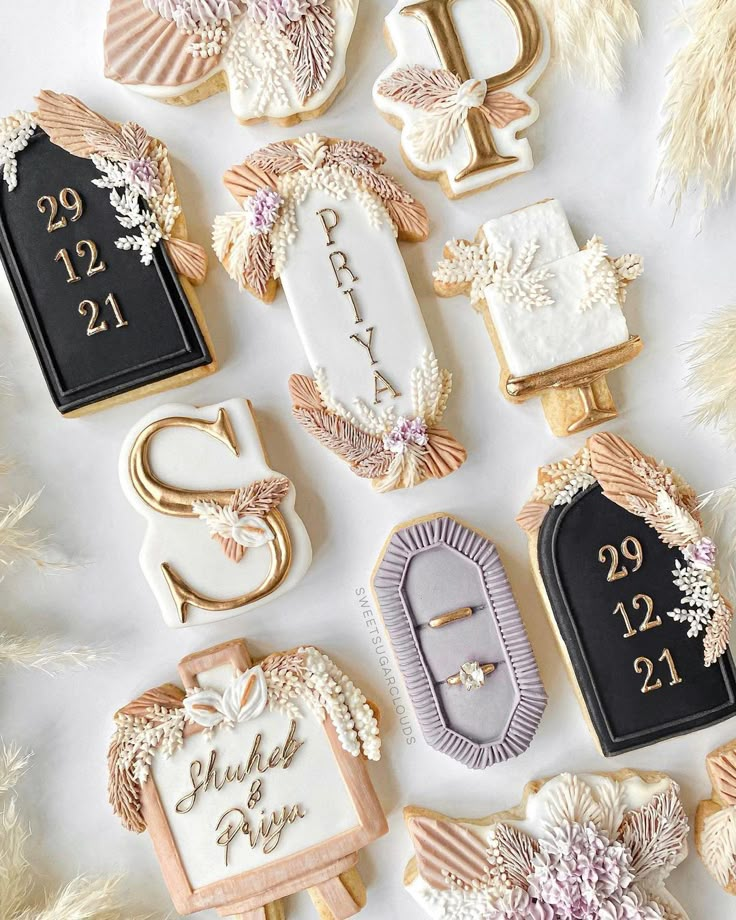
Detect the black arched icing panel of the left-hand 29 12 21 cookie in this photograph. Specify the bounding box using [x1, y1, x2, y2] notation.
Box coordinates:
[0, 131, 212, 412]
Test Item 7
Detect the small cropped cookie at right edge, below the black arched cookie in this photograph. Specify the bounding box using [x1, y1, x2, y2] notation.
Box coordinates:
[695, 741, 736, 894]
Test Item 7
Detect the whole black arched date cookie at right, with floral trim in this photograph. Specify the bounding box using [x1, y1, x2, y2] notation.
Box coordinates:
[517, 432, 736, 756]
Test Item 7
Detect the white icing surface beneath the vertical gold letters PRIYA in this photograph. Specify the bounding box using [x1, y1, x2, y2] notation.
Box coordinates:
[281, 190, 432, 415]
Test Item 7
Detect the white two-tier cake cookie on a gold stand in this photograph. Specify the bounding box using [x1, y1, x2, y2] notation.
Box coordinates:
[434, 200, 643, 437]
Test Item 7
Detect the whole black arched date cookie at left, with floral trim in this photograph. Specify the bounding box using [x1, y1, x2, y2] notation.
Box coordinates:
[0, 90, 217, 415]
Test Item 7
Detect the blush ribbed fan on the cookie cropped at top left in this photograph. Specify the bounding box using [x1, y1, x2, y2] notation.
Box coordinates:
[105, 0, 219, 86]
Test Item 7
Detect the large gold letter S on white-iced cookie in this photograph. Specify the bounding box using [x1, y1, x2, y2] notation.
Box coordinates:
[128, 409, 292, 623]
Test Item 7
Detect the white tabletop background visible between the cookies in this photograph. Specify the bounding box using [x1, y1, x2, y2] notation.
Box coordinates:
[0, 0, 736, 920]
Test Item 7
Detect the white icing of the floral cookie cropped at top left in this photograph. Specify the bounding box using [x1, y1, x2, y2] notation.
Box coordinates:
[118, 0, 359, 121]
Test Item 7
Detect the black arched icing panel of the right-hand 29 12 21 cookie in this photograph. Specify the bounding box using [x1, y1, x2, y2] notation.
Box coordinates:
[538, 485, 736, 756]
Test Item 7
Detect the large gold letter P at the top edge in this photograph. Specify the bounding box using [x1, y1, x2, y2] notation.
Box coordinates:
[401, 0, 542, 182]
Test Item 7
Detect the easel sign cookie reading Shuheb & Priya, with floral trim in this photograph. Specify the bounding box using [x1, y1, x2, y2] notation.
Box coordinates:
[108, 639, 388, 920]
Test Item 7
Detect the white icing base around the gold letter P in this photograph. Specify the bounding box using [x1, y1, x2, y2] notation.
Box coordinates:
[373, 0, 549, 195]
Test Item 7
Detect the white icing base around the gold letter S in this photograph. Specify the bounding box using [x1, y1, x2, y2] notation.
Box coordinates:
[120, 399, 312, 627]
